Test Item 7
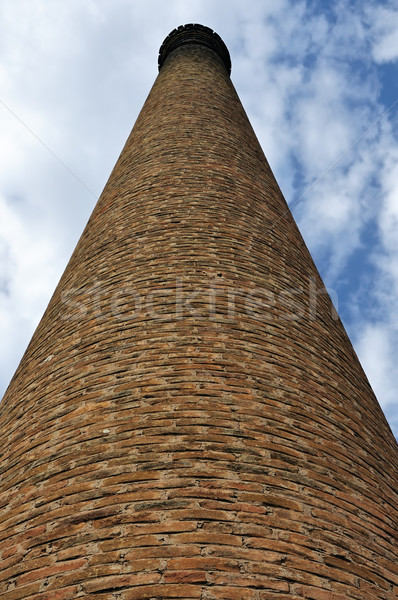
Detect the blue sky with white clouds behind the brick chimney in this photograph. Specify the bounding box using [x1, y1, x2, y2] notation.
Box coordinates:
[0, 0, 398, 436]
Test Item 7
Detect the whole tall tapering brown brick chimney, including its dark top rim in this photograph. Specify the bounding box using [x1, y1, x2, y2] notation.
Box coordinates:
[0, 25, 398, 600]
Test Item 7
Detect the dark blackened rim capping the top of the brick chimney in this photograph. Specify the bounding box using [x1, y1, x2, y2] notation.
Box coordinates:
[158, 23, 231, 75]
